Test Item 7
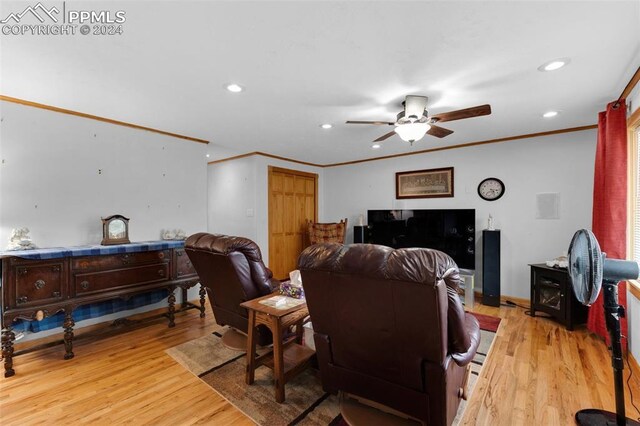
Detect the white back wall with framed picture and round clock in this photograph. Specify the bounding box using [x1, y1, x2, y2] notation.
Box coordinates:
[324, 130, 596, 299]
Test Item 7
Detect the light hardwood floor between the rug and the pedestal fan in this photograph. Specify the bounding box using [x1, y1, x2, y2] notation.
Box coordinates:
[462, 305, 640, 426]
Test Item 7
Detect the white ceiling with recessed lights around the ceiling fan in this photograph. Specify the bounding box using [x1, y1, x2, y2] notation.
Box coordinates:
[0, 0, 640, 164]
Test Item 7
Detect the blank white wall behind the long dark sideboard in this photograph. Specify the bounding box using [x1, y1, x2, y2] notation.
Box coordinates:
[0, 102, 207, 337]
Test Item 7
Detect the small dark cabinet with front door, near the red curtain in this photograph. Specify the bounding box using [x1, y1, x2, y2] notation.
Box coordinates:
[529, 263, 588, 330]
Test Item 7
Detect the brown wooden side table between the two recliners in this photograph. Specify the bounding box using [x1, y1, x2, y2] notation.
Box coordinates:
[240, 294, 315, 402]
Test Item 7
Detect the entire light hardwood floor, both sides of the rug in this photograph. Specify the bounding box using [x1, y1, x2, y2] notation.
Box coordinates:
[0, 304, 640, 425]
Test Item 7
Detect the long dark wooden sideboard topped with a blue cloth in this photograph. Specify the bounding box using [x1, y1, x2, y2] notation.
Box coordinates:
[0, 241, 205, 377]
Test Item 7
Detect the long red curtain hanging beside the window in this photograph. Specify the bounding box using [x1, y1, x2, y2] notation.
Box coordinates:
[587, 100, 627, 348]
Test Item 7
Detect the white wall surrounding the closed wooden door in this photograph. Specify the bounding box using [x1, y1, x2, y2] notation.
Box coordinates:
[207, 155, 325, 265]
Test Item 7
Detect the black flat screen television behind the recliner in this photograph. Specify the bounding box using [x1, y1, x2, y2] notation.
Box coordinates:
[367, 209, 476, 269]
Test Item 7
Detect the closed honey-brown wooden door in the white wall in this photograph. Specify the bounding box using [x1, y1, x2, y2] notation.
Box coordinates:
[269, 167, 318, 279]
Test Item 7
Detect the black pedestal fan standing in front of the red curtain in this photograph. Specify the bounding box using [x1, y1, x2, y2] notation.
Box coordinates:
[569, 229, 640, 426]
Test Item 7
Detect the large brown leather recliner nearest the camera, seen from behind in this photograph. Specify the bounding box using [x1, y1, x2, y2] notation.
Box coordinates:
[298, 243, 480, 425]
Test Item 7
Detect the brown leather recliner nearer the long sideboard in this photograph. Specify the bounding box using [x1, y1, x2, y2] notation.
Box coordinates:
[185, 232, 280, 346]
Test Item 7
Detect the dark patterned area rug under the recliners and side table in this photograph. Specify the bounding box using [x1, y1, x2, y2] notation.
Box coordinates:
[167, 314, 500, 426]
